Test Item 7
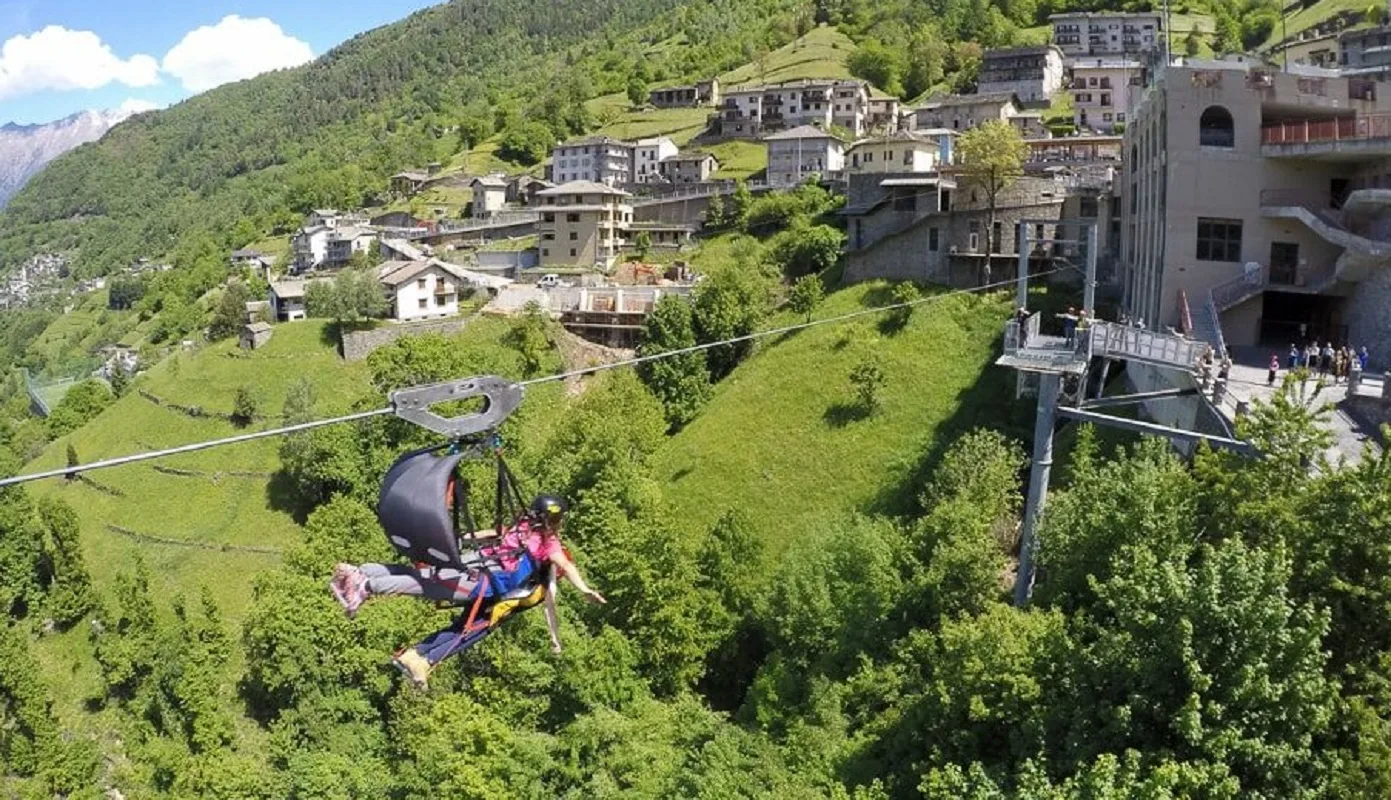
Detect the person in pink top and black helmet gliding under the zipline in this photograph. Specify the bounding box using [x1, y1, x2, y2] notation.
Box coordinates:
[330, 495, 606, 685]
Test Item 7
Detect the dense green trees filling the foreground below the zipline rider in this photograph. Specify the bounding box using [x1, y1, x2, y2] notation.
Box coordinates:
[8, 284, 1391, 799]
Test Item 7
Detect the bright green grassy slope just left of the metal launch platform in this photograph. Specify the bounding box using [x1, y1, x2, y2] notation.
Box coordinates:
[658, 282, 1028, 551]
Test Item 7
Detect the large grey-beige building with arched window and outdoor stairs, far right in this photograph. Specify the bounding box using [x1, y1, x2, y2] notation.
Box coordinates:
[1123, 61, 1391, 365]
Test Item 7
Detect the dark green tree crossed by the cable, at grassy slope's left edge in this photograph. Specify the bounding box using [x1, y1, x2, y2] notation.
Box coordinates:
[637, 295, 711, 429]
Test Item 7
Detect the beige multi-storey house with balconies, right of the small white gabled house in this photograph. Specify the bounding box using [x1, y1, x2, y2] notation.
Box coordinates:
[537, 181, 633, 267]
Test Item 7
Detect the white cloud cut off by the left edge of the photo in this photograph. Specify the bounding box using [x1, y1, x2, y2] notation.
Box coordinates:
[0, 25, 160, 100]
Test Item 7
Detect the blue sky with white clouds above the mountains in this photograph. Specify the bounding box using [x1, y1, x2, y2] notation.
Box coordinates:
[0, 0, 434, 124]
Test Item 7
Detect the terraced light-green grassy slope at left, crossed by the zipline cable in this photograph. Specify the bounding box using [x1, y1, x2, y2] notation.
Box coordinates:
[26, 321, 367, 619]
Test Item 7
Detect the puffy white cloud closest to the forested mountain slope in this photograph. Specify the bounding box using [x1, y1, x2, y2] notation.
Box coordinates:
[164, 14, 314, 92]
